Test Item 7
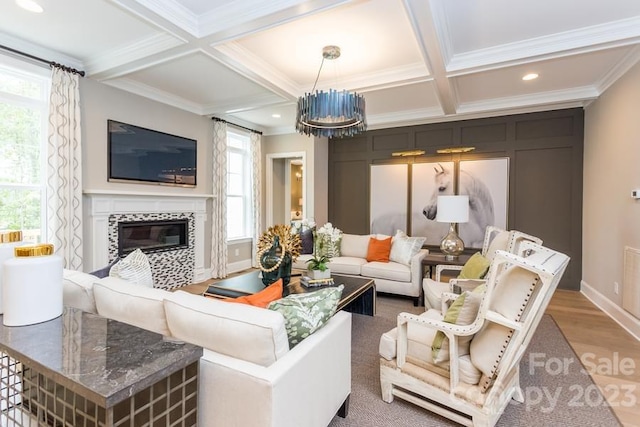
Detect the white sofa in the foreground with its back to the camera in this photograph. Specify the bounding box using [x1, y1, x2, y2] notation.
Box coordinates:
[64, 270, 351, 427]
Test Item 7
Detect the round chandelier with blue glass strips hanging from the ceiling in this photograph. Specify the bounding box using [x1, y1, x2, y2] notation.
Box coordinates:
[296, 46, 367, 138]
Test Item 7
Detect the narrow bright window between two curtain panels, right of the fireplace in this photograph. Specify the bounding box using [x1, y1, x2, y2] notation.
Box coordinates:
[227, 131, 251, 240]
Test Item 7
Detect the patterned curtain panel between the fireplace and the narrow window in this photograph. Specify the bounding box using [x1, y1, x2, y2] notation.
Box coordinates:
[211, 121, 227, 278]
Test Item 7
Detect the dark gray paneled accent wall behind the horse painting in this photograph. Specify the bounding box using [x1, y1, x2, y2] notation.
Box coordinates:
[328, 108, 584, 289]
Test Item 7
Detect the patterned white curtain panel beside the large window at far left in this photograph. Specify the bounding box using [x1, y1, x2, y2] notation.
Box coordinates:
[46, 67, 82, 271]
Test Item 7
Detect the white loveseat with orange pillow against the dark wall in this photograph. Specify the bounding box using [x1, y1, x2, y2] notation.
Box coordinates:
[293, 233, 429, 305]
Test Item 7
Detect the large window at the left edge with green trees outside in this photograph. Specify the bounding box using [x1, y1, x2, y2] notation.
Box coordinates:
[0, 56, 50, 243]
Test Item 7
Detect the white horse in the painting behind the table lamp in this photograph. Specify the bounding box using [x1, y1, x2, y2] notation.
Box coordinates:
[422, 164, 495, 248]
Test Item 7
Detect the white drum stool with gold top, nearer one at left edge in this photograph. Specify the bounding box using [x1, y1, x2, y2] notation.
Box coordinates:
[2, 244, 63, 326]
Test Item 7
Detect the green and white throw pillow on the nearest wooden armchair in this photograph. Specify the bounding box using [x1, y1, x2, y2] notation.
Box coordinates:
[431, 285, 487, 363]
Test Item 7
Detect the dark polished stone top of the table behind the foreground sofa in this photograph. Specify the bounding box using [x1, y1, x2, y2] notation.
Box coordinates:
[0, 308, 202, 408]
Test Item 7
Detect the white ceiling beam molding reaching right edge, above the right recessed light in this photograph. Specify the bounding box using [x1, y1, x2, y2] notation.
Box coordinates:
[447, 17, 640, 76]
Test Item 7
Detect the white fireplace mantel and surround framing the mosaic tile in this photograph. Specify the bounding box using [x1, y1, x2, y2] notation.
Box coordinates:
[83, 190, 214, 282]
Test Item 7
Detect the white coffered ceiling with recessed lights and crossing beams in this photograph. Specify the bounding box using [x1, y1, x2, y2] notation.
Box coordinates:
[0, 0, 640, 134]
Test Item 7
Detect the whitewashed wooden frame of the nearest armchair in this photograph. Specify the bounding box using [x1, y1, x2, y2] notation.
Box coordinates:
[380, 242, 569, 426]
